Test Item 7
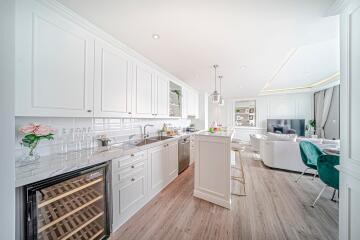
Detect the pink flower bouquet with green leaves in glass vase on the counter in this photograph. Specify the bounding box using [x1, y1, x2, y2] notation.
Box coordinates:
[19, 123, 55, 156]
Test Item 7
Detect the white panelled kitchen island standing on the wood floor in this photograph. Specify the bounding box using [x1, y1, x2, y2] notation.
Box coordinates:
[194, 131, 234, 208]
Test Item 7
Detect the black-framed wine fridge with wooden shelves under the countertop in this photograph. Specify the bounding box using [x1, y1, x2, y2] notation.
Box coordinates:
[24, 163, 110, 240]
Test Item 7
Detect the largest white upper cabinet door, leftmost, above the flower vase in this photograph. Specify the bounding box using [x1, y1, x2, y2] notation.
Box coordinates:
[15, 1, 94, 117]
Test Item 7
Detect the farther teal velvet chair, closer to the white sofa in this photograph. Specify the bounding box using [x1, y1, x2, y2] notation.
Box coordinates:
[295, 141, 323, 182]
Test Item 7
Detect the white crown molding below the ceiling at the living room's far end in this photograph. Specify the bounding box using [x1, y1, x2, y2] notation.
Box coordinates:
[259, 72, 340, 96]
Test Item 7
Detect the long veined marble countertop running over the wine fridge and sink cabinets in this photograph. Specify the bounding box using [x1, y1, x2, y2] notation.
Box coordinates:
[15, 133, 196, 187]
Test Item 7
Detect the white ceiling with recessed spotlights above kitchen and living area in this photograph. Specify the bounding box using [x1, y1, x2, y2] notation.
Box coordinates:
[58, 0, 339, 98]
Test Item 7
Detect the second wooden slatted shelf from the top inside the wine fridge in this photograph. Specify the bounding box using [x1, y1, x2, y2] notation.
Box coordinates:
[38, 189, 103, 233]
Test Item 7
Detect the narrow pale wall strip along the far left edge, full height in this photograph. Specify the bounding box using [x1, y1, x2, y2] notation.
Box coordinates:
[0, 0, 15, 240]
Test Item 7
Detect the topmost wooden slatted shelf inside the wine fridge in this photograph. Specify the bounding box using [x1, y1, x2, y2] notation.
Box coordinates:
[38, 176, 103, 208]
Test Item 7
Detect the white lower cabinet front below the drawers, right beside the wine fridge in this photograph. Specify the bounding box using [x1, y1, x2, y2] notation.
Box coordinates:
[113, 174, 148, 231]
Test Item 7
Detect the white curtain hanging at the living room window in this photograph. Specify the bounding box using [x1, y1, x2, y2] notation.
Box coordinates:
[315, 87, 334, 138]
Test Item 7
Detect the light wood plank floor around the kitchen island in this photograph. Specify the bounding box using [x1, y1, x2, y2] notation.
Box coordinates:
[111, 147, 338, 240]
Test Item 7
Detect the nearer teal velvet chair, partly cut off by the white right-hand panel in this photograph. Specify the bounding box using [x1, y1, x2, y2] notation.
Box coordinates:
[312, 154, 340, 207]
